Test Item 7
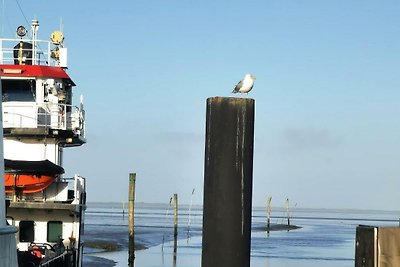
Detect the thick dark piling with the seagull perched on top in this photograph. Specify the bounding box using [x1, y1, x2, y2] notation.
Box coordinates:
[202, 97, 255, 267]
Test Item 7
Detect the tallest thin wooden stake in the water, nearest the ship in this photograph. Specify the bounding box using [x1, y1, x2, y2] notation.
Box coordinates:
[128, 173, 136, 267]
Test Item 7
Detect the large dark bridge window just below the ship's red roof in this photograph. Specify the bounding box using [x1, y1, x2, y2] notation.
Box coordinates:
[1, 79, 36, 102]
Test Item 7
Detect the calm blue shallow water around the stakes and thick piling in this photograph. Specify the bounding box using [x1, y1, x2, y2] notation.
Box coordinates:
[84, 204, 399, 267]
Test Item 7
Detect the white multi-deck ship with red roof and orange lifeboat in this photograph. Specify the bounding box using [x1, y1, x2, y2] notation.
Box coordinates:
[0, 20, 86, 267]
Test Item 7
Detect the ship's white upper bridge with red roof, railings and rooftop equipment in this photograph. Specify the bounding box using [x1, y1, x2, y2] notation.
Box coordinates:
[0, 24, 85, 146]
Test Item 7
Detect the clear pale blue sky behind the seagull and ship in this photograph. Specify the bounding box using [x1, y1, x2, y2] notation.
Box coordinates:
[1, 0, 400, 210]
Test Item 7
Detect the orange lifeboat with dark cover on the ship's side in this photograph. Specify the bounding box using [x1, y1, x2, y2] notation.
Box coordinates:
[4, 159, 64, 194]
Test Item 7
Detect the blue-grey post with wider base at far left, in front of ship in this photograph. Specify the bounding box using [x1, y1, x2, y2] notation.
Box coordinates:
[0, 74, 18, 267]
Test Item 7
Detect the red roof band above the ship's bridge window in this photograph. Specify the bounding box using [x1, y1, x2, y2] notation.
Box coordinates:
[0, 65, 71, 80]
